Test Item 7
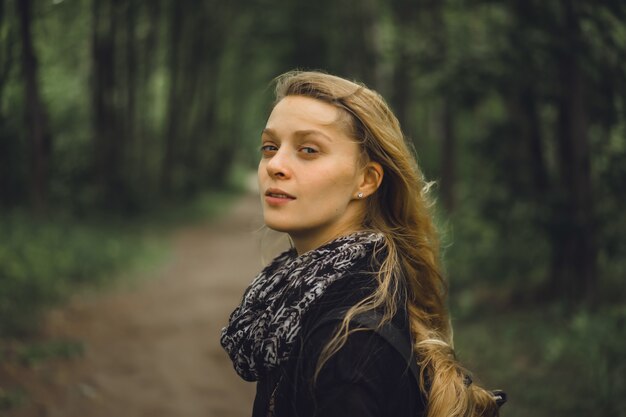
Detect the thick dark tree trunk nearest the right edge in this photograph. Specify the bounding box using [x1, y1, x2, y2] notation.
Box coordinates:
[551, 0, 597, 301]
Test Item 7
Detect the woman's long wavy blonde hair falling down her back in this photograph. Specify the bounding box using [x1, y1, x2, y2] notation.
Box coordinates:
[276, 71, 498, 417]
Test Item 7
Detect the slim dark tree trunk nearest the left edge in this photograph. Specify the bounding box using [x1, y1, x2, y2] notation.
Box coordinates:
[17, 0, 52, 213]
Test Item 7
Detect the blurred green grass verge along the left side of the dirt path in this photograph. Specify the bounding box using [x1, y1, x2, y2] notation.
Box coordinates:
[0, 188, 236, 334]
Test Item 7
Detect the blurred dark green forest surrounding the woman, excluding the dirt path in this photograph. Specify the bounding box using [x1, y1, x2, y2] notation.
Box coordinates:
[0, 0, 626, 416]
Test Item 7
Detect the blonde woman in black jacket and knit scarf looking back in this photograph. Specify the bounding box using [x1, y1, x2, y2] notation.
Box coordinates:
[221, 72, 498, 417]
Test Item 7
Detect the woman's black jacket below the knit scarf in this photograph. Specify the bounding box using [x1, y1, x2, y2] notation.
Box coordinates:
[252, 274, 424, 417]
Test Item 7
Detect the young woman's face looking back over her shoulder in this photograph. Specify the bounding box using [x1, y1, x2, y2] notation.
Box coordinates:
[258, 96, 363, 253]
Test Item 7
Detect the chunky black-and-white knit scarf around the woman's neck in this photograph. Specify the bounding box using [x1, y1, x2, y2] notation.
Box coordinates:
[220, 232, 383, 381]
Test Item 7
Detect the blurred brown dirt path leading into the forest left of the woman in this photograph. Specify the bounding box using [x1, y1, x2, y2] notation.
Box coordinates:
[5, 195, 286, 417]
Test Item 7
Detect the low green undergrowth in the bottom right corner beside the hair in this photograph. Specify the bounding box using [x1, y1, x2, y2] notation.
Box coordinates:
[455, 306, 626, 417]
